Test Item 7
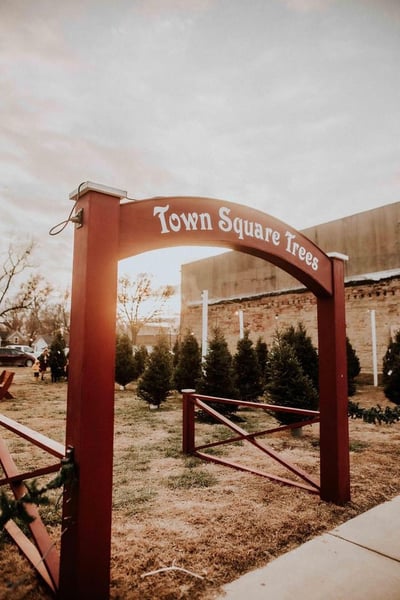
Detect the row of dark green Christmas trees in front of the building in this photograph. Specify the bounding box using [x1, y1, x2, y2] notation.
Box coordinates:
[115, 323, 400, 423]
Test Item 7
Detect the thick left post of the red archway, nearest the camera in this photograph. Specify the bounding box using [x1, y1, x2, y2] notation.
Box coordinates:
[59, 183, 126, 600]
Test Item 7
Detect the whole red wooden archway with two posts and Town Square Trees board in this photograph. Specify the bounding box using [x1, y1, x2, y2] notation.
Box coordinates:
[59, 182, 350, 600]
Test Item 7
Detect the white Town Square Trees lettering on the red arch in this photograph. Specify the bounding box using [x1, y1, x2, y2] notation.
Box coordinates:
[153, 204, 318, 271]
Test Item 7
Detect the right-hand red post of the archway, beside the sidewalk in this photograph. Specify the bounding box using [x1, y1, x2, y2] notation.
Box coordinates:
[318, 255, 350, 504]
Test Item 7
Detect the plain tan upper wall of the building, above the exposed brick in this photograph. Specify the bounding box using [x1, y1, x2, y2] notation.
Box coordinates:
[181, 202, 400, 305]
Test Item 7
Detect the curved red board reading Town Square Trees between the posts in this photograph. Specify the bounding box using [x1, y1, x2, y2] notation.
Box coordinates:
[119, 196, 332, 295]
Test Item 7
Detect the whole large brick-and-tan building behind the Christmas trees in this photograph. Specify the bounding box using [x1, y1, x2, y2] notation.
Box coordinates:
[181, 202, 400, 380]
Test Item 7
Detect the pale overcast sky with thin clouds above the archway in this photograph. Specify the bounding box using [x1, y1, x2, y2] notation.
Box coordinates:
[0, 0, 400, 300]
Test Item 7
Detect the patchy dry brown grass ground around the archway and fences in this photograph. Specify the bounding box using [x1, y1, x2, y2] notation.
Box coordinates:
[0, 369, 400, 600]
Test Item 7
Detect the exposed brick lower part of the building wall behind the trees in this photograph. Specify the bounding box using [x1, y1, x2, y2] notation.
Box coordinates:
[181, 277, 400, 374]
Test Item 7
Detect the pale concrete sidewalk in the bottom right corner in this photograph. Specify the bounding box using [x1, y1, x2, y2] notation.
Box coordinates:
[220, 496, 400, 600]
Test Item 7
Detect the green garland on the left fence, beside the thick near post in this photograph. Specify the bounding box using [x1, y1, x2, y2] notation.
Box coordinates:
[0, 452, 76, 530]
